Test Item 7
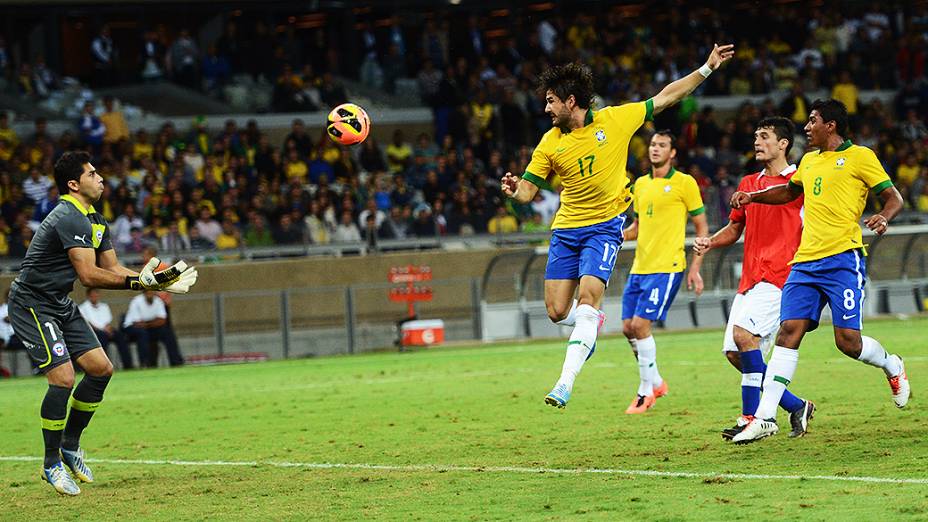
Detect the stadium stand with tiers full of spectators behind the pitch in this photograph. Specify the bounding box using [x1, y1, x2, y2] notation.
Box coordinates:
[0, 3, 928, 258]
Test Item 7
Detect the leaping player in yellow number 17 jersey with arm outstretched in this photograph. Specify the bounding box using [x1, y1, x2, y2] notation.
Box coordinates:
[502, 45, 734, 408]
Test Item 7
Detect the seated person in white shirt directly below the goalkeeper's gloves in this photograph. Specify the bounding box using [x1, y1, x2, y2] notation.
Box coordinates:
[116, 290, 184, 368]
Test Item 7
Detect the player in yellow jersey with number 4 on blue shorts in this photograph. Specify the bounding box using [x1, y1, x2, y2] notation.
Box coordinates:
[622, 130, 709, 413]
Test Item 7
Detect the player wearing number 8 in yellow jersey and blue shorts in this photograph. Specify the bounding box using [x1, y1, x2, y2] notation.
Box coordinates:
[731, 100, 909, 444]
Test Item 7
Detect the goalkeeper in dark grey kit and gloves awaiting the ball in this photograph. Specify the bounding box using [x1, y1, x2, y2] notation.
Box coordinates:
[9, 152, 197, 495]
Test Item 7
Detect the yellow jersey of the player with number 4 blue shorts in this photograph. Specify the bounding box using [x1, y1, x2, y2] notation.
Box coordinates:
[631, 167, 706, 274]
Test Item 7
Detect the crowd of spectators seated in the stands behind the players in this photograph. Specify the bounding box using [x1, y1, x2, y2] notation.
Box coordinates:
[0, 4, 928, 256]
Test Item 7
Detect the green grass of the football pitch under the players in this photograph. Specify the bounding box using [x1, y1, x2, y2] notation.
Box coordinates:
[0, 317, 928, 521]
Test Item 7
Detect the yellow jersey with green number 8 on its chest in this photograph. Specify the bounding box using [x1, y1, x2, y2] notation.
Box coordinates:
[789, 140, 893, 263]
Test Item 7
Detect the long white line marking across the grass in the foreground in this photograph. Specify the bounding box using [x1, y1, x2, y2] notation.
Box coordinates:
[0, 456, 928, 484]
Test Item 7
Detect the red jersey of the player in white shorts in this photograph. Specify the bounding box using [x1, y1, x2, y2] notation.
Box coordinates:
[729, 165, 803, 294]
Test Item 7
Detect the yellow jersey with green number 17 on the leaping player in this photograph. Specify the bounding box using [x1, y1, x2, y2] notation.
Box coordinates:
[522, 99, 654, 230]
